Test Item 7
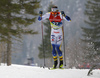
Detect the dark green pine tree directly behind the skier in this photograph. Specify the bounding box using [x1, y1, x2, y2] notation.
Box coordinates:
[38, 3, 53, 59]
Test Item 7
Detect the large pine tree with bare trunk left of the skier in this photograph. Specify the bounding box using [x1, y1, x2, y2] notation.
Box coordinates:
[0, 0, 39, 66]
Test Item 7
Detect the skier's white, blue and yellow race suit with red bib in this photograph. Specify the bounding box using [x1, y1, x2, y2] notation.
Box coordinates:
[38, 12, 71, 60]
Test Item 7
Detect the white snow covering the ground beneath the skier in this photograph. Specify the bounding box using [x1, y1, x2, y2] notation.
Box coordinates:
[0, 65, 100, 78]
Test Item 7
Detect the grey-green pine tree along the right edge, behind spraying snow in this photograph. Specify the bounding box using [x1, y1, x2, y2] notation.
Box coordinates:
[82, 0, 100, 61]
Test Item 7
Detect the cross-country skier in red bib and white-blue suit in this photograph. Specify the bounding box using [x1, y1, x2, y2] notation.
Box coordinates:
[38, 6, 71, 69]
